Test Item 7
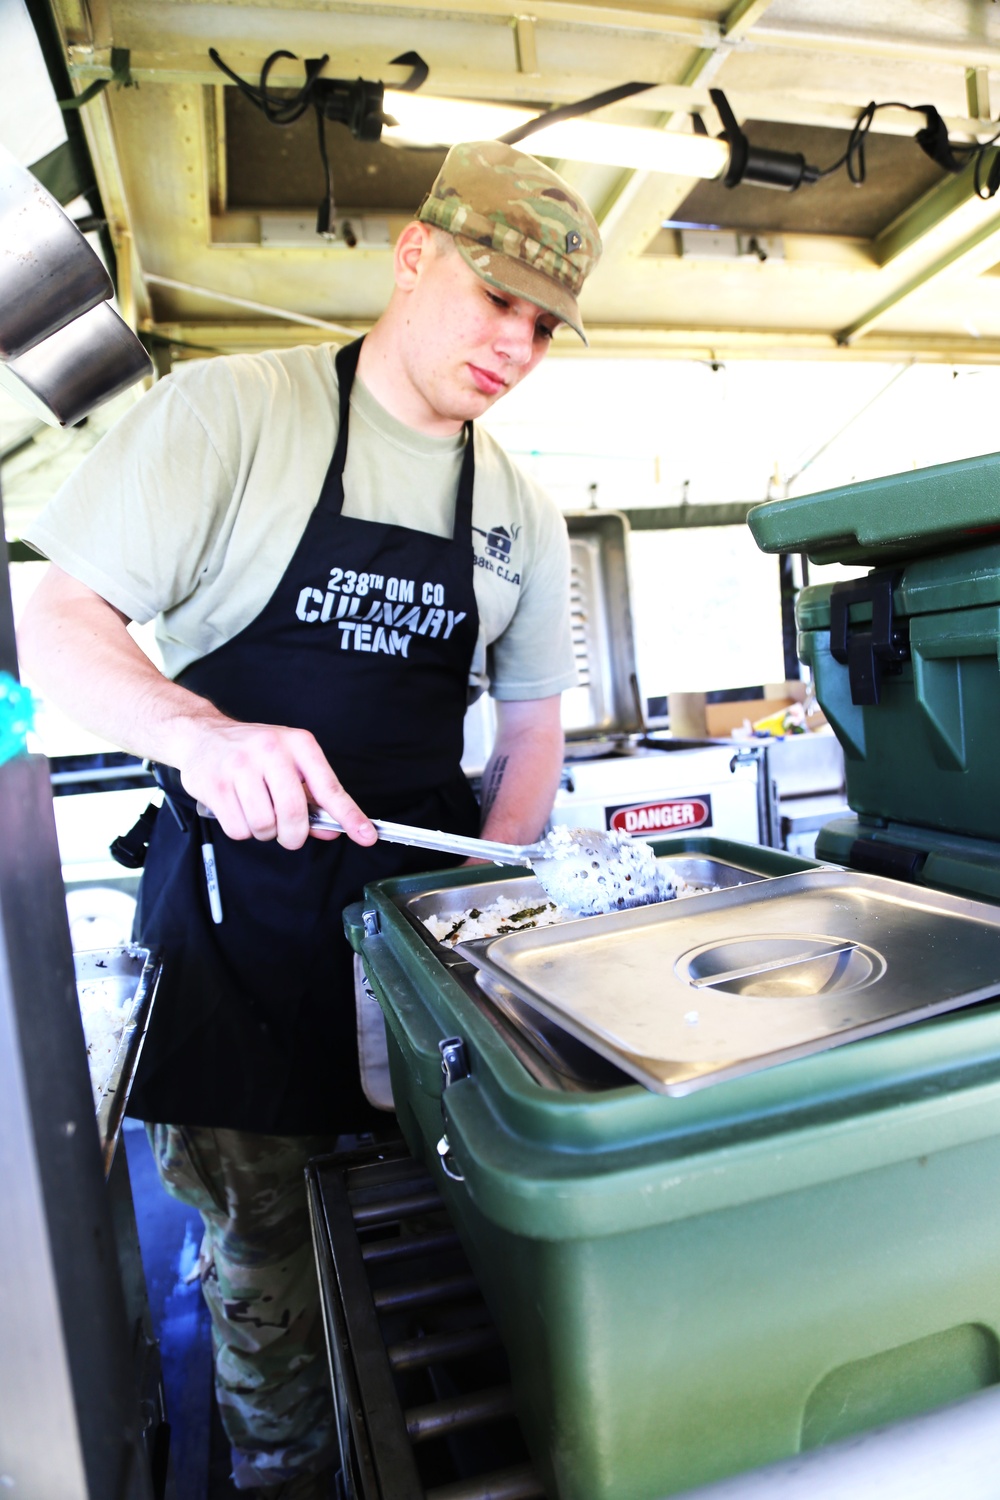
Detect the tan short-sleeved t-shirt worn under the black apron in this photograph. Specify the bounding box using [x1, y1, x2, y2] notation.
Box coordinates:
[25, 345, 577, 701]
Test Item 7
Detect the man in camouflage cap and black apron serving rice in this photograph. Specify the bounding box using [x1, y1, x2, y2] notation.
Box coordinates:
[21, 143, 600, 1500]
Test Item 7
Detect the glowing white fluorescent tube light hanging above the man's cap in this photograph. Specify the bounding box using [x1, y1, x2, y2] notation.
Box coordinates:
[384, 89, 729, 179]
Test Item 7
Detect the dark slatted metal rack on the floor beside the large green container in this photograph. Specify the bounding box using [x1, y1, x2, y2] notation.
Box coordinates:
[307, 1142, 546, 1500]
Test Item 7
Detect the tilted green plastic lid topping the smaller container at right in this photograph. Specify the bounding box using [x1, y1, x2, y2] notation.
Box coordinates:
[747, 453, 1000, 567]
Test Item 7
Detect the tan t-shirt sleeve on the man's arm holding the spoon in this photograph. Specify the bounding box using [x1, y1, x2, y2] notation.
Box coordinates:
[24, 360, 235, 624]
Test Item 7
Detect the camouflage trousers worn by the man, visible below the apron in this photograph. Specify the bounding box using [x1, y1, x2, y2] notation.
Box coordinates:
[145, 1125, 336, 1490]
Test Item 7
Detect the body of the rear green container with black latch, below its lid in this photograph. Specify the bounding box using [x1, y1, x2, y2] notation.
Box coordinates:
[796, 543, 1000, 840]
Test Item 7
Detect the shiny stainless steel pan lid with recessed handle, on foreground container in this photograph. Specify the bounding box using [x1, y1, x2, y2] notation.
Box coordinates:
[466, 869, 1000, 1094]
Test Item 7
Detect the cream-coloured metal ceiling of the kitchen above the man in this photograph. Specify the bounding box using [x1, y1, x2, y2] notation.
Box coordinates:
[37, 0, 1000, 360]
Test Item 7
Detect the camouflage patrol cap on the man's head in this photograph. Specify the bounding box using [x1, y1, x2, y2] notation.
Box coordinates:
[417, 141, 601, 344]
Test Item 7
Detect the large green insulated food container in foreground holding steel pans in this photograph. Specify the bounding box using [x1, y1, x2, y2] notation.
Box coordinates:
[346, 840, 1000, 1500]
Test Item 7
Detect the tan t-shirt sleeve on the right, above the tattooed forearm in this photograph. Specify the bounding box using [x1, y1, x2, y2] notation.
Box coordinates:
[487, 474, 577, 702]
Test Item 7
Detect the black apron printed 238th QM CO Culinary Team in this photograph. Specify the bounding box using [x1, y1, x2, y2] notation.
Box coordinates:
[129, 341, 478, 1134]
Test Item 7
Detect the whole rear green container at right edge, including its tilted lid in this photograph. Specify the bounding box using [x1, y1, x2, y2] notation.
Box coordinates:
[748, 453, 1000, 864]
